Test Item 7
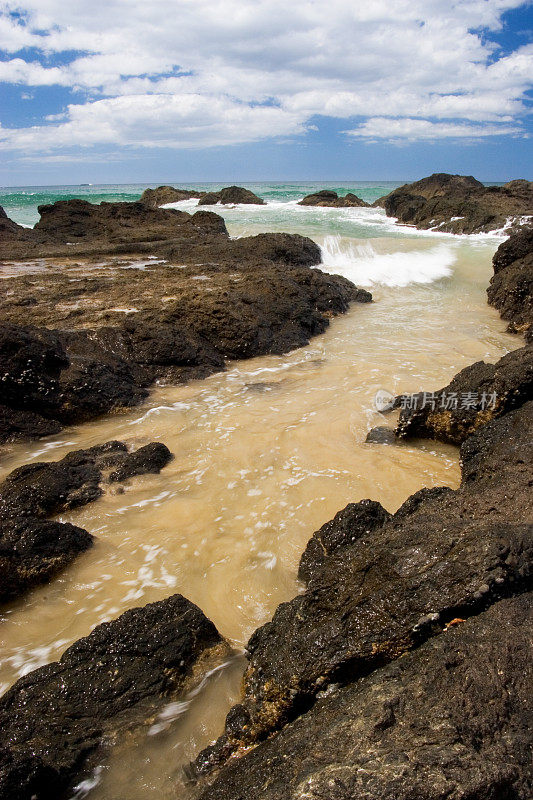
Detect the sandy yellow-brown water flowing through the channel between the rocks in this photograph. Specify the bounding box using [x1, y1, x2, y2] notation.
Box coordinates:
[0, 220, 519, 800]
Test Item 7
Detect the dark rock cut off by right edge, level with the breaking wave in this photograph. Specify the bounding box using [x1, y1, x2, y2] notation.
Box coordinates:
[487, 228, 533, 340]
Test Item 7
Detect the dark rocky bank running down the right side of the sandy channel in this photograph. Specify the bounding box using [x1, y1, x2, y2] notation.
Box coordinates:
[186, 222, 533, 800]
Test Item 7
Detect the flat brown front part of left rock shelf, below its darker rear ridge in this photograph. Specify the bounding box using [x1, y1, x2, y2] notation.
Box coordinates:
[0, 250, 372, 442]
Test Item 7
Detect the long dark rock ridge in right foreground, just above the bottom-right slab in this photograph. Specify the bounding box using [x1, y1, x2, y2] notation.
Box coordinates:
[192, 402, 533, 772]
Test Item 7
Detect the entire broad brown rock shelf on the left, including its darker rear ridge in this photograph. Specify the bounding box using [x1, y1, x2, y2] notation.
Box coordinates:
[0, 200, 372, 443]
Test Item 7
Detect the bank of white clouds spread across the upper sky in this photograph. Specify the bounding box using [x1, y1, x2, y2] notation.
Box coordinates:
[0, 0, 533, 152]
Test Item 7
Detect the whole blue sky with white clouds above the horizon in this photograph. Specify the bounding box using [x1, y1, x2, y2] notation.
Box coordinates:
[0, 0, 533, 186]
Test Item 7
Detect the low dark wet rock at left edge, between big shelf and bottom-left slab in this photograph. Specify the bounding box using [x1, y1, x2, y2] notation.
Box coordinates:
[0, 442, 172, 603]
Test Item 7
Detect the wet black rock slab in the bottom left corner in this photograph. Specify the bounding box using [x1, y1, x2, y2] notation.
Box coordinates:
[0, 595, 222, 800]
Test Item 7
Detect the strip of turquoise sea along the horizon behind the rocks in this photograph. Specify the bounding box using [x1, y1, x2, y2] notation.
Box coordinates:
[0, 181, 401, 226]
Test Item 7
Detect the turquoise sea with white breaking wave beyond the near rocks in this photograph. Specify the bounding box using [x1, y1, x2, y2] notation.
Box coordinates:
[0, 181, 501, 287]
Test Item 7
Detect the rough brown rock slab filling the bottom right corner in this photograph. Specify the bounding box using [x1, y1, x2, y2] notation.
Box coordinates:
[196, 595, 533, 800]
